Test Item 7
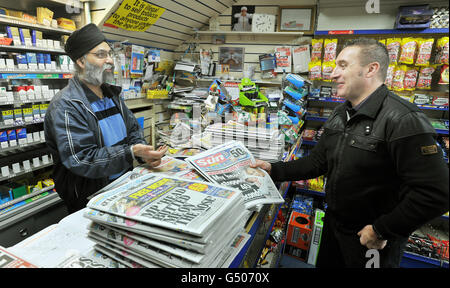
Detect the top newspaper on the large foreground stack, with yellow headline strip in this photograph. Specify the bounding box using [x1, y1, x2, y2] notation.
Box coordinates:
[87, 173, 244, 237]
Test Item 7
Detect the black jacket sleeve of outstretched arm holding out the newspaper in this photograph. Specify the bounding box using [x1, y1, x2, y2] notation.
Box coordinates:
[270, 133, 328, 181]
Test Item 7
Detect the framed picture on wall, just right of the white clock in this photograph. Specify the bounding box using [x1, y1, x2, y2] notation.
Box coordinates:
[278, 6, 316, 34]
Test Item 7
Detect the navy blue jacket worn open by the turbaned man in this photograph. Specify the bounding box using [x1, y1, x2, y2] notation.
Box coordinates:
[44, 76, 146, 212]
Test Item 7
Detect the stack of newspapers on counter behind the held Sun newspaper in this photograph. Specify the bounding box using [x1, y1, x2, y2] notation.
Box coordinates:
[205, 121, 284, 162]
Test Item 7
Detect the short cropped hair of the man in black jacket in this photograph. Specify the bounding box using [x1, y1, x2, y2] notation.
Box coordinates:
[344, 38, 389, 82]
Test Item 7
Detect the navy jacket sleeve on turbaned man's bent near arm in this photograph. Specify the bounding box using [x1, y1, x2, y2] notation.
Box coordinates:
[45, 100, 133, 178]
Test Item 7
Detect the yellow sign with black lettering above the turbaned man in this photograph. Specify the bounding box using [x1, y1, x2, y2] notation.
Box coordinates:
[105, 0, 166, 32]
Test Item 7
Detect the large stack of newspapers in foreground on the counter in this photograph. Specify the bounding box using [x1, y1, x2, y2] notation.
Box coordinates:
[84, 173, 249, 268]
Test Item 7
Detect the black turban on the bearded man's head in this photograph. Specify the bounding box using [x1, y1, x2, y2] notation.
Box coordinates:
[64, 23, 106, 62]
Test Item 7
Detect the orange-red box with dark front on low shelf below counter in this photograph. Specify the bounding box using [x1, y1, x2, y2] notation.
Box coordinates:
[286, 211, 312, 251]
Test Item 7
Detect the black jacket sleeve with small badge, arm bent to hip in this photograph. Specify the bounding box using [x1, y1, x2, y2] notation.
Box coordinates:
[373, 113, 449, 239]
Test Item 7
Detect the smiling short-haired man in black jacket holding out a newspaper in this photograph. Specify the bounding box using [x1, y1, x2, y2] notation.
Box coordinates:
[254, 39, 449, 267]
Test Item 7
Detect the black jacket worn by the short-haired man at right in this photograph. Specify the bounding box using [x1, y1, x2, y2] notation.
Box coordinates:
[271, 85, 449, 239]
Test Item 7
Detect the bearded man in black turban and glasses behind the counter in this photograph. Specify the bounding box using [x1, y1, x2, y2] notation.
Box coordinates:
[44, 24, 167, 213]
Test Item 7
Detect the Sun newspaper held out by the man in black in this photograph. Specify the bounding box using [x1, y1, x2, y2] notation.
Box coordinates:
[185, 141, 284, 209]
